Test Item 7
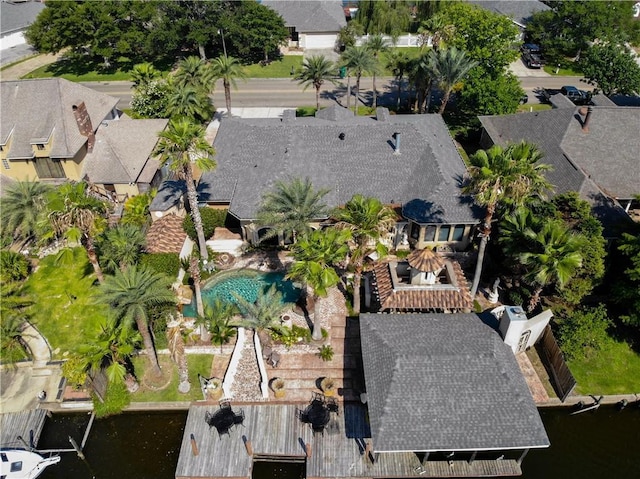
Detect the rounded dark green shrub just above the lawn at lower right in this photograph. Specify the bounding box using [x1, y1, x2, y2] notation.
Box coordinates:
[558, 304, 611, 359]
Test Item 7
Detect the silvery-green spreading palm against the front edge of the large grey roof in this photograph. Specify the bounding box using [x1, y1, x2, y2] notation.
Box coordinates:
[257, 177, 329, 242]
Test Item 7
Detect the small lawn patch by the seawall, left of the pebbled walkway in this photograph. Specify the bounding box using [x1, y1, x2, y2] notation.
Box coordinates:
[131, 354, 213, 402]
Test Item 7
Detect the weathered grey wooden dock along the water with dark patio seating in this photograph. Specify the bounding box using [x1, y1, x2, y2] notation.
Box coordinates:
[176, 403, 522, 479]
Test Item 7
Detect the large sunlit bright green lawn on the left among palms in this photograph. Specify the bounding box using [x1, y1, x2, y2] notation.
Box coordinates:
[26, 248, 107, 359]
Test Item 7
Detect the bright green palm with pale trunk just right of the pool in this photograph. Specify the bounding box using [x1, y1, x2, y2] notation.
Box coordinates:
[287, 228, 351, 341]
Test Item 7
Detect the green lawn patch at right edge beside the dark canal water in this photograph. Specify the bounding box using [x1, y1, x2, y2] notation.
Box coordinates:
[568, 339, 640, 395]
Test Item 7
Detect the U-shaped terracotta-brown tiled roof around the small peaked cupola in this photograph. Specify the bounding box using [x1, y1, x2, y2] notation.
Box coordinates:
[373, 260, 473, 311]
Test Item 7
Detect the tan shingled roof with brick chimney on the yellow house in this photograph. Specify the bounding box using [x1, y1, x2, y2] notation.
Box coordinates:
[0, 78, 118, 160]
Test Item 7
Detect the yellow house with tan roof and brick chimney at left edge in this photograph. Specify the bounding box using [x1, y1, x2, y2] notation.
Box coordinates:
[0, 78, 120, 182]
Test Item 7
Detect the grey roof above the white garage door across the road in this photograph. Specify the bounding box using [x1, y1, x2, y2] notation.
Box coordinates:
[262, 0, 347, 33]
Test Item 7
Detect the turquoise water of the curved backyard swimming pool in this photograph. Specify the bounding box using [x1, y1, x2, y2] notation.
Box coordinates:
[182, 269, 301, 317]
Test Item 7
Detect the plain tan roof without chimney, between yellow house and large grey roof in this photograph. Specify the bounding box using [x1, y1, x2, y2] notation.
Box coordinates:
[83, 116, 168, 184]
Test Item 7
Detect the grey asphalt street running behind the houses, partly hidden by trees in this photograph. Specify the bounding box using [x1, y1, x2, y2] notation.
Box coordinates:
[83, 76, 592, 109]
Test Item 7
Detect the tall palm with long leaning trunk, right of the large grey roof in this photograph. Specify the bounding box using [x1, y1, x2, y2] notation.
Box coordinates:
[463, 142, 552, 298]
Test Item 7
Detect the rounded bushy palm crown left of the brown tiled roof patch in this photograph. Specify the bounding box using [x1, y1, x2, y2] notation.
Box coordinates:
[98, 224, 145, 273]
